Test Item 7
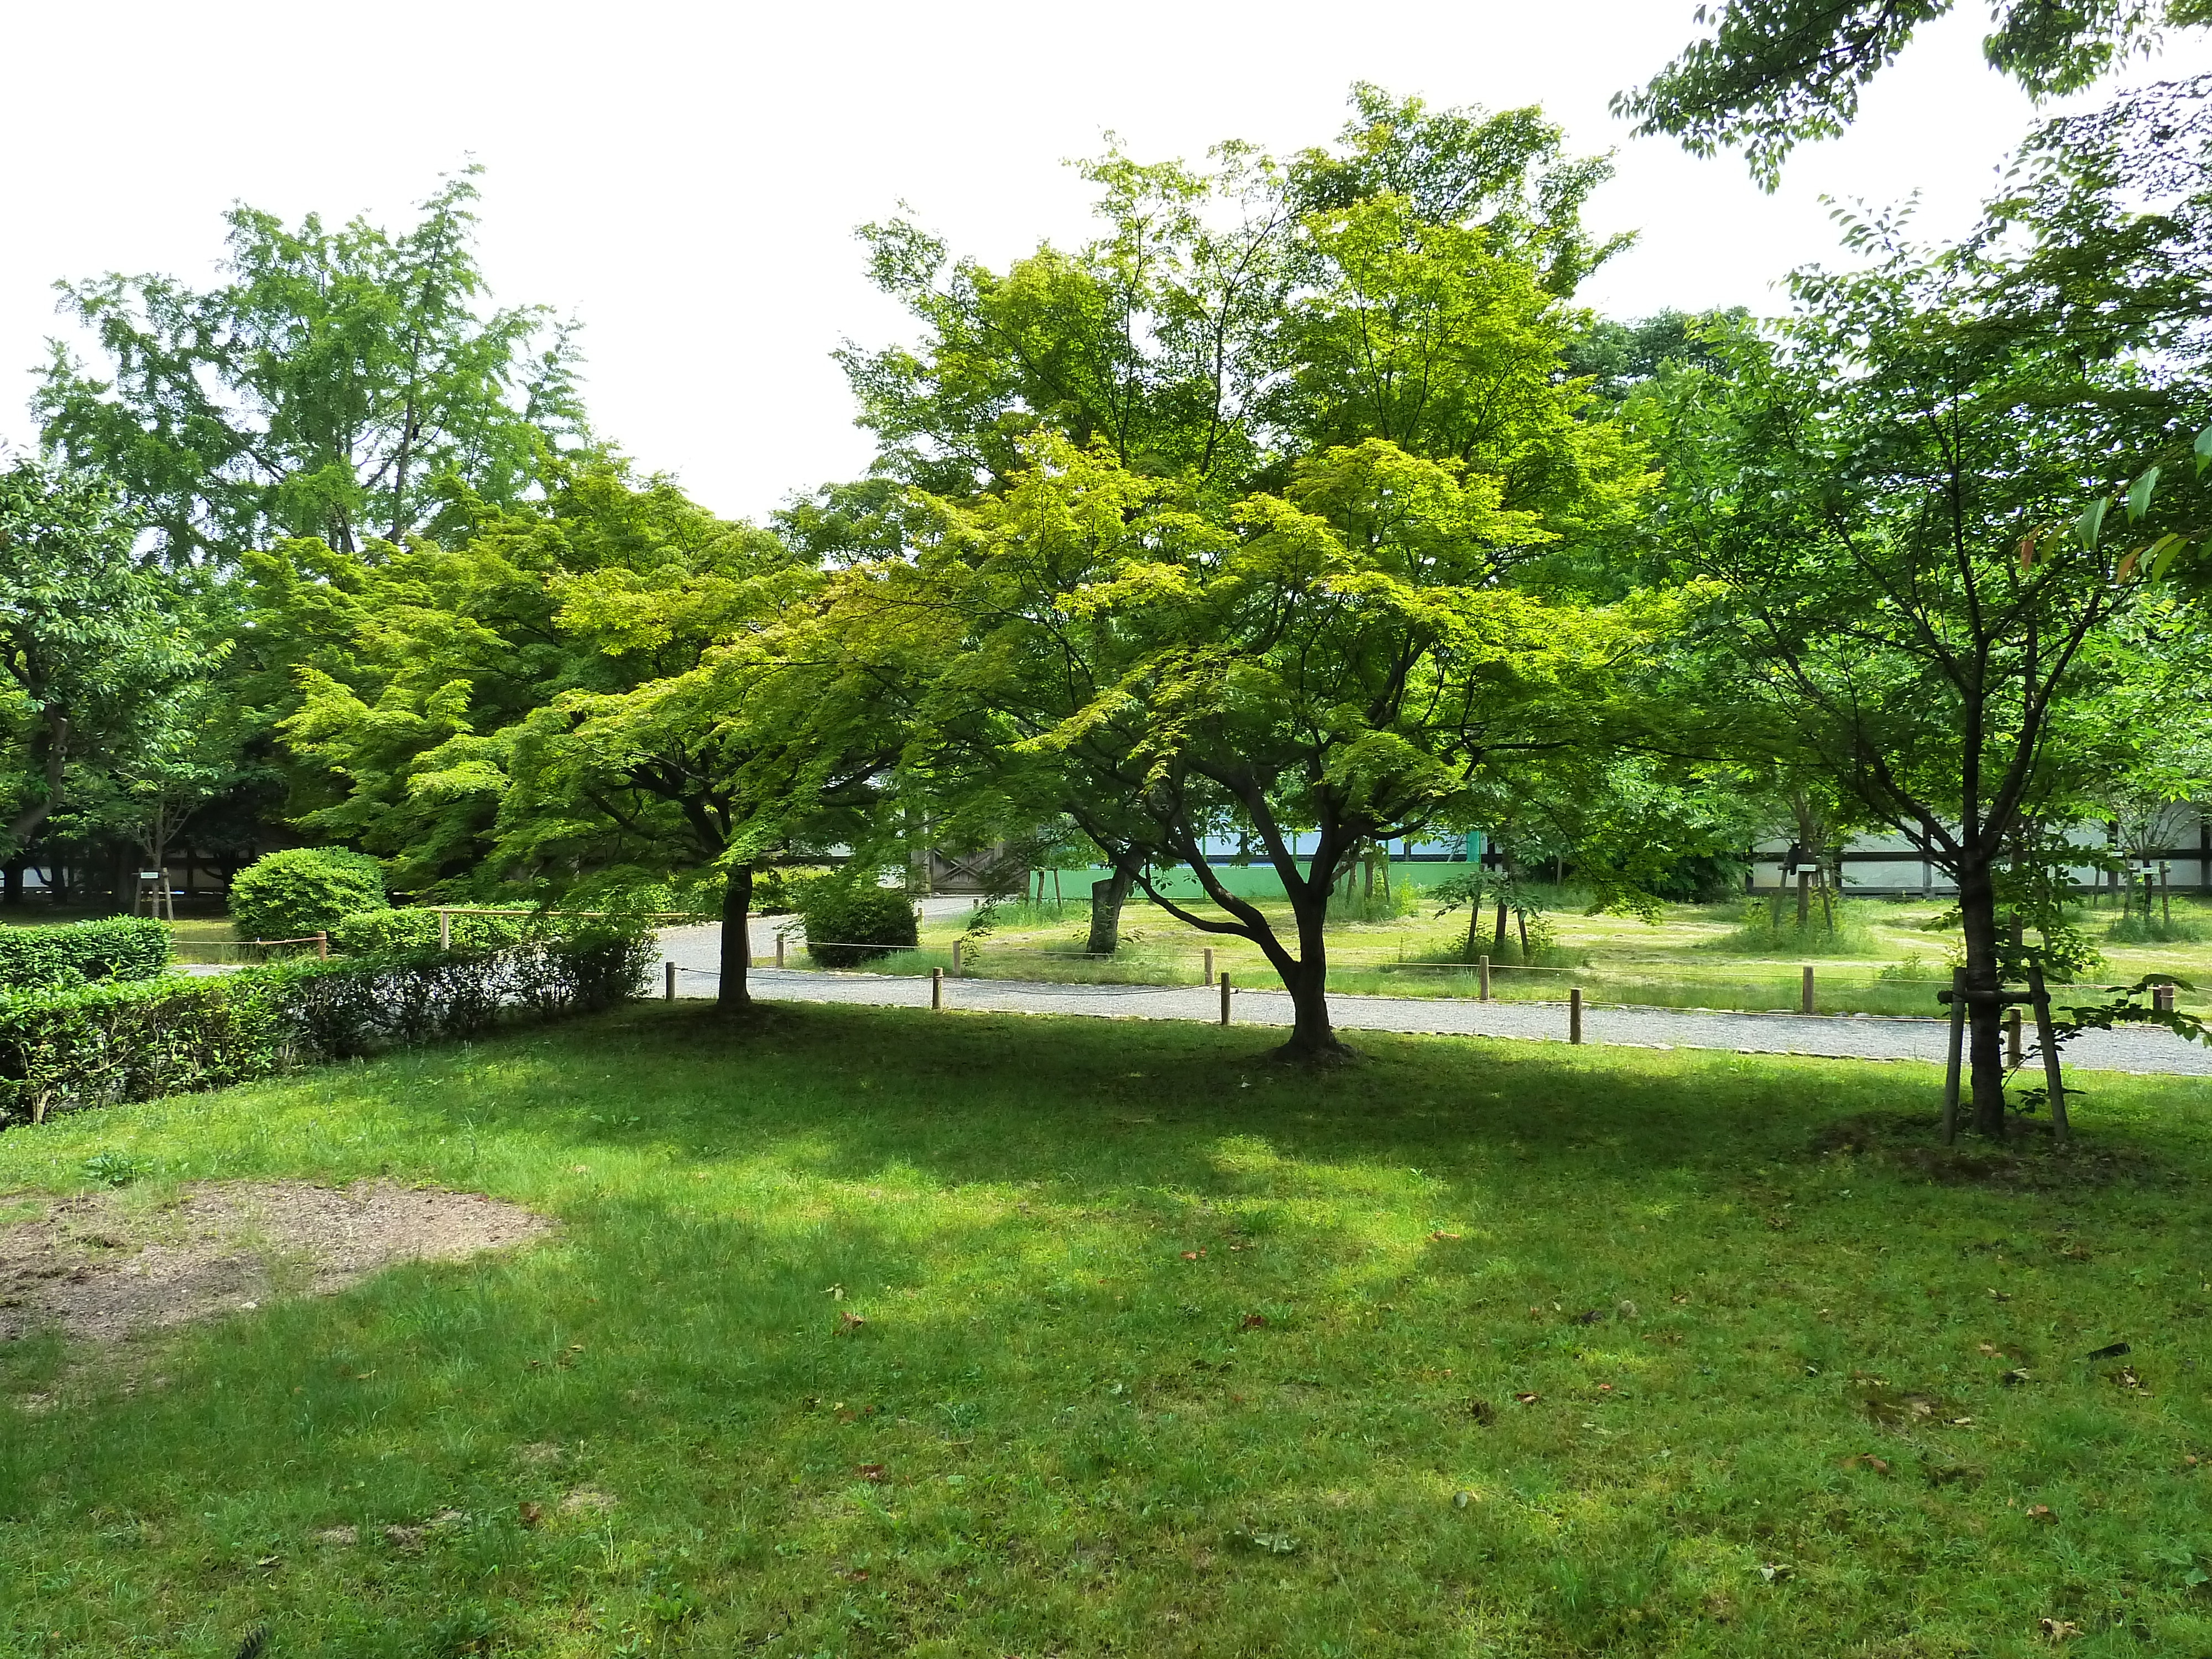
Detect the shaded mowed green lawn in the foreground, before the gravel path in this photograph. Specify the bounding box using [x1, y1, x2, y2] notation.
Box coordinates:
[0, 1004, 2212, 1659]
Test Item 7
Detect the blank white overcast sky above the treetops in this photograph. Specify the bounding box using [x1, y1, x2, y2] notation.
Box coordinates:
[0, 0, 2212, 515]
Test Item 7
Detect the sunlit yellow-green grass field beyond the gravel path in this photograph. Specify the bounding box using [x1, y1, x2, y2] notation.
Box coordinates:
[849, 894, 2212, 1015]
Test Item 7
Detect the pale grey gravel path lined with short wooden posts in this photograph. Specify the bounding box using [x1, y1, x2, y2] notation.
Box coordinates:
[661, 925, 2212, 1077]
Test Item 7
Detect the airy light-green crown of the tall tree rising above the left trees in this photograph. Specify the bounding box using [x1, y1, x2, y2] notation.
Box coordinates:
[35, 166, 584, 568]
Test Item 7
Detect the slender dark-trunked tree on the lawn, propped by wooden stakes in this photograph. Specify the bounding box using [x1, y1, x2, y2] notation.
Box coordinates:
[1668, 153, 2203, 1133]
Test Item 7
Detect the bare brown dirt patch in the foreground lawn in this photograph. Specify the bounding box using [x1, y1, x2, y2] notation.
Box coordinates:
[0, 1181, 553, 1340]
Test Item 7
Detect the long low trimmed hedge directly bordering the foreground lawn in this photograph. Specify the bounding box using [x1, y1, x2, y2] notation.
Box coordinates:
[0, 929, 650, 1128]
